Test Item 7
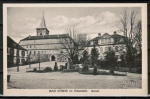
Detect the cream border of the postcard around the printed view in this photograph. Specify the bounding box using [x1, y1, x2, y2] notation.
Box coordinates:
[3, 3, 148, 96]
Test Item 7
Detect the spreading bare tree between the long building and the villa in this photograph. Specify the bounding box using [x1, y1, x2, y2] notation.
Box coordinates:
[56, 27, 88, 64]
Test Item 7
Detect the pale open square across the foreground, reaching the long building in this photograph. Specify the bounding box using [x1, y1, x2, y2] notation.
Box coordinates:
[7, 62, 142, 89]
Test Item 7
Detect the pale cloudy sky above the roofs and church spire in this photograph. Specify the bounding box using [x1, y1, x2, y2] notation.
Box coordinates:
[7, 7, 141, 43]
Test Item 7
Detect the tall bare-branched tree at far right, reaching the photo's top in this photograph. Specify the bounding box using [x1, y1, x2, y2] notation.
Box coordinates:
[117, 9, 142, 71]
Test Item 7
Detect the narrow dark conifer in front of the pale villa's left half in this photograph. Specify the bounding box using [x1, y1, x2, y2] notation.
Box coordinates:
[91, 43, 99, 66]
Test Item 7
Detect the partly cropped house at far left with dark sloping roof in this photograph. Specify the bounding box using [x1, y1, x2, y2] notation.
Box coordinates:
[7, 36, 27, 67]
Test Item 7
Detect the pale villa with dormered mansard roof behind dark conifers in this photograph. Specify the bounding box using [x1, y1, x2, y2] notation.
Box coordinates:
[86, 32, 126, 61]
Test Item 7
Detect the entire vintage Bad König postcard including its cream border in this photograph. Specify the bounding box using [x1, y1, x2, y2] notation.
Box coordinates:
[3, 3, 147, 96]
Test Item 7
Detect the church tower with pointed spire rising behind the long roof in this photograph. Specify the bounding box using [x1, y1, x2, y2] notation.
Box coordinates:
[36, 12, 49, 36]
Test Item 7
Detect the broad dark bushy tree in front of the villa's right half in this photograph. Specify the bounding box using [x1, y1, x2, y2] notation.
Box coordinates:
[105, 49, 117, 73]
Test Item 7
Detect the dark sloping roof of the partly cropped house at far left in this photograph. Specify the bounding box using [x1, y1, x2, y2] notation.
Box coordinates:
[7, 36, 26, 50]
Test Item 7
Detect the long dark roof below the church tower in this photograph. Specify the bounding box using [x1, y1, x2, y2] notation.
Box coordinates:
[21, 34, 69, 41]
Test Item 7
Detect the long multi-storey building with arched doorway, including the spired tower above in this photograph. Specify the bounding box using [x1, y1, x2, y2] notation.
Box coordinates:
[19, 14, 71, 61]
